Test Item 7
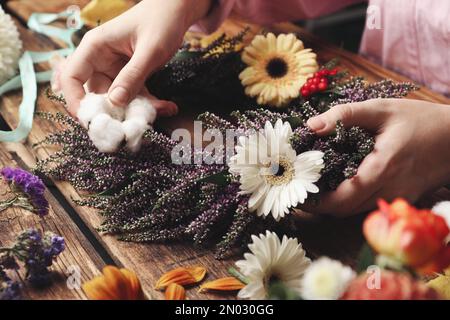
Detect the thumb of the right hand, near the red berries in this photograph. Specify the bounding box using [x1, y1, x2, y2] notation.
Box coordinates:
[307, 99, 385, 135]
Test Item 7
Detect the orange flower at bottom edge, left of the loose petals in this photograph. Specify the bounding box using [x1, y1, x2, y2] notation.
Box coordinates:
[82, 266, 145, 300]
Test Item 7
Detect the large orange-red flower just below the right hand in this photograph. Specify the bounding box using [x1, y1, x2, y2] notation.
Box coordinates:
[363, 199, 450, 273]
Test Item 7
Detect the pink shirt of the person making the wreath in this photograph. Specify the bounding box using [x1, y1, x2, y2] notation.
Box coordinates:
[199, 0, 450, 95]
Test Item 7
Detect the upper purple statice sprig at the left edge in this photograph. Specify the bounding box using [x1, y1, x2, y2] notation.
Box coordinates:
[0, 167, 49, 217]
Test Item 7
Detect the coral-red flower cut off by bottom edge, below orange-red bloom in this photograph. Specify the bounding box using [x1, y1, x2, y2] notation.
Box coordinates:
[341, 270, 440, 300]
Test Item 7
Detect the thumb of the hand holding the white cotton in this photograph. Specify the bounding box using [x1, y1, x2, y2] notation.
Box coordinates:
[108, 47, 156, 106]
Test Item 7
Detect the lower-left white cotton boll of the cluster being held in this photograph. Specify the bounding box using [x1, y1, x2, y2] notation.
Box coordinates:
[88, 113, 125, 153]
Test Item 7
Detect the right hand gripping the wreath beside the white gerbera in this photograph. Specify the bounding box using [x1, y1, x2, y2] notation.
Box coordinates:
[302, 99, 450, 216]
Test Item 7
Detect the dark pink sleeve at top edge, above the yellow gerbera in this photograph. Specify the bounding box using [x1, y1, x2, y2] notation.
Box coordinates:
[196, 0, 366, 33]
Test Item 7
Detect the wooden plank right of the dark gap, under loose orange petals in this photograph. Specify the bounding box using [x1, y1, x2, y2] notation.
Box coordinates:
[0, 17, 237, 299]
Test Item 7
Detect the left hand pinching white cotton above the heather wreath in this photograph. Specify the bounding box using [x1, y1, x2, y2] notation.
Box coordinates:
[59, 0, 211, 115]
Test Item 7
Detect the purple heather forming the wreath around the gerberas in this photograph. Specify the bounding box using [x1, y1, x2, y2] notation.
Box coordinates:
[36, 51, 415, 258]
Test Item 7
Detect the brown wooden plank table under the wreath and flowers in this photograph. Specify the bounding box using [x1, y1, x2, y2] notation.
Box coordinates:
[0, 0, 450, 299]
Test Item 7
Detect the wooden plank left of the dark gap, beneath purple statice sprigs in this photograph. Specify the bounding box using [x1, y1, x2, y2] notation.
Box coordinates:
[0, 144, 104, 300]
